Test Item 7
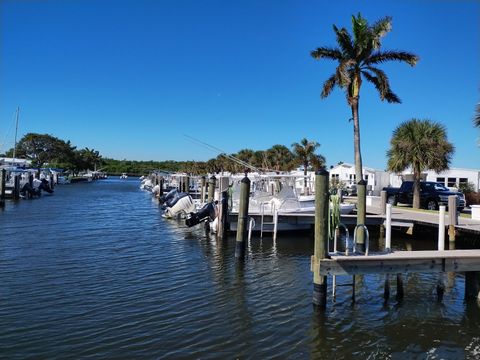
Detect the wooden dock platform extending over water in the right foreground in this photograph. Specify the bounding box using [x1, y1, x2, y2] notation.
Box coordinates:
[320, 250, 480, 275]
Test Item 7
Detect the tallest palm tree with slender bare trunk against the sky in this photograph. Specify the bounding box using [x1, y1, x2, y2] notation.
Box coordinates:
[310, 14, 419, 181]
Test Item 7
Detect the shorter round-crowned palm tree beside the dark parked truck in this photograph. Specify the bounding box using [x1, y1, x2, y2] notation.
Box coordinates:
[387, 119, 455, 209]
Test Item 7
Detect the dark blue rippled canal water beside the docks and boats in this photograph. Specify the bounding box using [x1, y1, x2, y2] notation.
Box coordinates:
[0, 179, 480, 359]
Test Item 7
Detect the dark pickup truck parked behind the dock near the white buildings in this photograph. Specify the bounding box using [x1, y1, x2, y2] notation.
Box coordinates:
[383, 181, 465, 211]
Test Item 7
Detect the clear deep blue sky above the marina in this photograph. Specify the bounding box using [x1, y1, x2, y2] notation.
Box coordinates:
[0, 0, 480, 169]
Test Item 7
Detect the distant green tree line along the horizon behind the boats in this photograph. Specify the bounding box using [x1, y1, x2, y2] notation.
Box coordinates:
[3, 133, 325, 175]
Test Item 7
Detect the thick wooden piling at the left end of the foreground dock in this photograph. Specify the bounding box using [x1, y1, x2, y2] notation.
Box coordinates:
[311, 170, 329, 309]
